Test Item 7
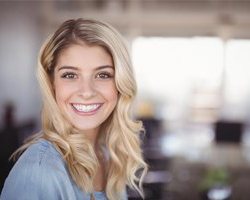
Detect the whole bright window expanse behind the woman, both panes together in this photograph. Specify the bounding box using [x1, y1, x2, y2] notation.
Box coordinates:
[132, 37, 250, 121]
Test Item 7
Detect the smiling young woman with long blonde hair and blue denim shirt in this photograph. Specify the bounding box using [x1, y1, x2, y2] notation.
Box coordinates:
[1, 19, 147, 200]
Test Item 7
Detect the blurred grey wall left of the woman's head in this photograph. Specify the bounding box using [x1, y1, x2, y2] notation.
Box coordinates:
[0, 2, 42, 125]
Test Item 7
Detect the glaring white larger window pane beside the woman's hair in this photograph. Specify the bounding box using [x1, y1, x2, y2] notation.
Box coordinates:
[132, 37, 223, 99]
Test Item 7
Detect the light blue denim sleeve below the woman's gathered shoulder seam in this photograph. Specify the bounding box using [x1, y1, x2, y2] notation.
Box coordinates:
[0, 144, 76, 200]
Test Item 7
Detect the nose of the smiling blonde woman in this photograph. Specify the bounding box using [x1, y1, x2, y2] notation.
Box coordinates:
[79, 78, 96, 99]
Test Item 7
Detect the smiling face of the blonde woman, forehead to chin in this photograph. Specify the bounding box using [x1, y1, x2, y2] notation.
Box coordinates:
[54, 44, 118, 136]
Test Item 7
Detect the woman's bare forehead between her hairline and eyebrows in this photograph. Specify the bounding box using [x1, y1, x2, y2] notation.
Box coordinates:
[57, 44, 113, 67]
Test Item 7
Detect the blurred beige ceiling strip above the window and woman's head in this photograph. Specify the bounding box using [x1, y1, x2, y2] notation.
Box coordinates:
[40, 0, 250, 40]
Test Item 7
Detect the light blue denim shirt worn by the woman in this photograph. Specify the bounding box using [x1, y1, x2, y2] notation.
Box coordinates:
[0, 139, 117, 200]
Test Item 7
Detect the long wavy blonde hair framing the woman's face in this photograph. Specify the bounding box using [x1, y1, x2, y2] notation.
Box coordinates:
[15, 19, 147, 200]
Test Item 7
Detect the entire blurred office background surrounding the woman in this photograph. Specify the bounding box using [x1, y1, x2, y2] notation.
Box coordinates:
[0, 0, 250, 200]
